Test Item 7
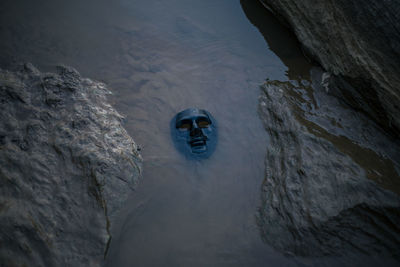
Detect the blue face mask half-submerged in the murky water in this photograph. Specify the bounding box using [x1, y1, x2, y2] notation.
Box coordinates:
[171, 108, 217, 158]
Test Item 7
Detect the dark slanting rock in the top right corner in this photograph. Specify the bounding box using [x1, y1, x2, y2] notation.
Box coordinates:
[260, 0, 400, 136]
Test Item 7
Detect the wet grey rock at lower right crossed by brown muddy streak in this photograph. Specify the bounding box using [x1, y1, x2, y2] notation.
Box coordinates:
[259, 68, 400, 266]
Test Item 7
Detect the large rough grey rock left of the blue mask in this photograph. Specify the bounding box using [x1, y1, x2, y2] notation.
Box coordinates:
[0, 64, 141, 266]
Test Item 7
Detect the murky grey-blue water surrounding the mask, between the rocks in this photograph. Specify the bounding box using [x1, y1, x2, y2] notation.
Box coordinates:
[0, 0, 398, 266]
